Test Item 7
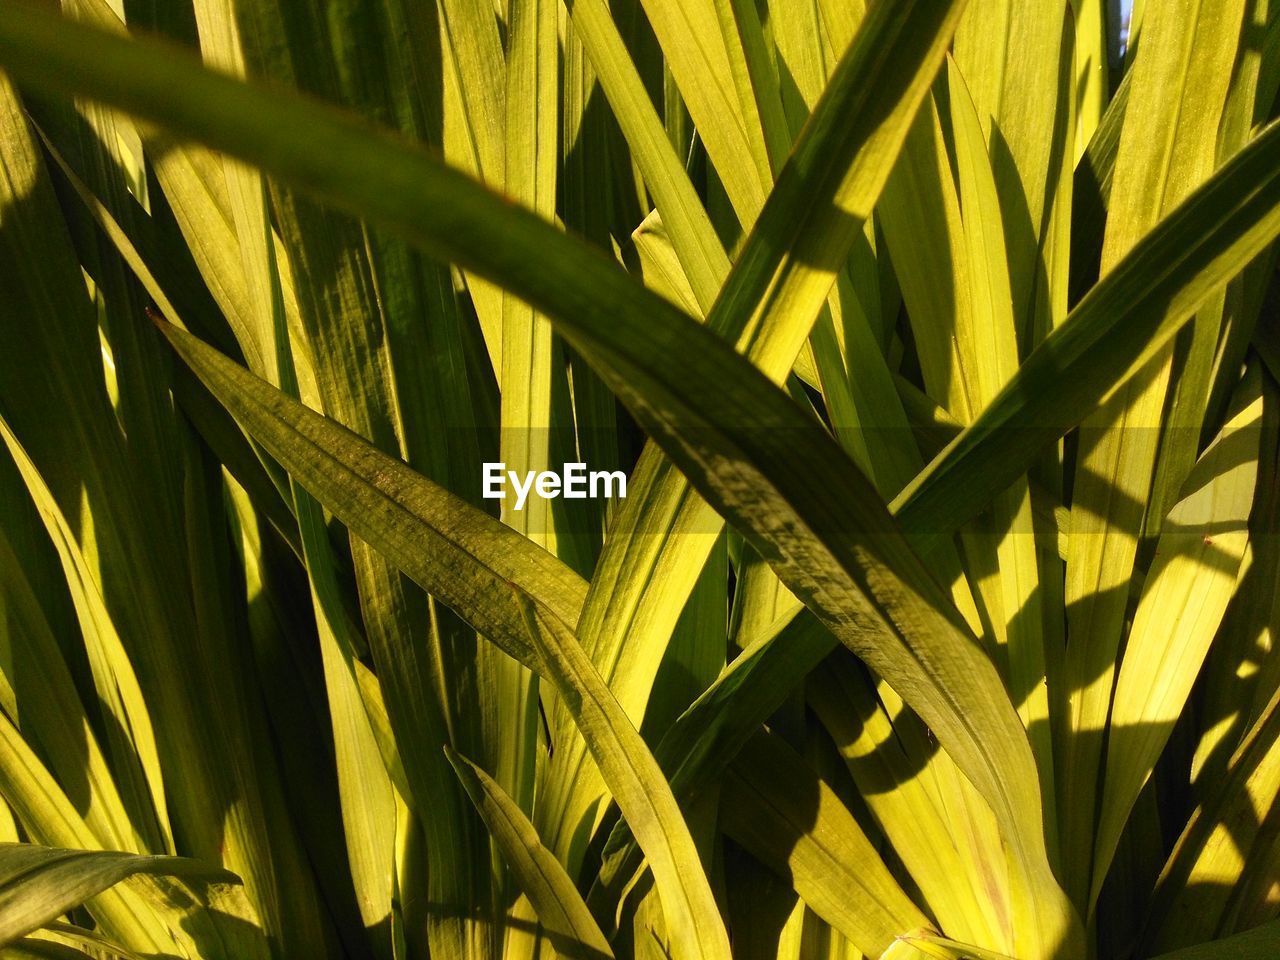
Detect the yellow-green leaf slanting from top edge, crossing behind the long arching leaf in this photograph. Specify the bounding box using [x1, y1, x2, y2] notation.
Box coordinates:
[541, 3, 960, 880]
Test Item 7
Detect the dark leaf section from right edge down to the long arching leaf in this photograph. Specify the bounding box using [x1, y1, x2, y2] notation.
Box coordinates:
[893, 125, 1280, 552]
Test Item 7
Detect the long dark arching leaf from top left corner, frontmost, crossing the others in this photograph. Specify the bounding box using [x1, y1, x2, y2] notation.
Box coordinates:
[0, 16, 1074, 950]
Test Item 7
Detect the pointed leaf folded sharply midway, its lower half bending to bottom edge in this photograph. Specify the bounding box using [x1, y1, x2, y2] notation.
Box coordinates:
[157, 328, 728, 957]
